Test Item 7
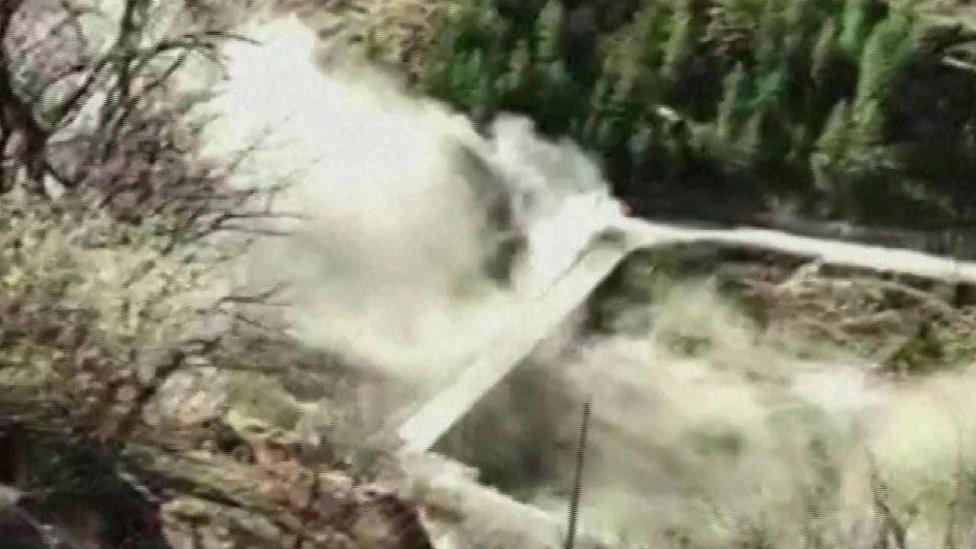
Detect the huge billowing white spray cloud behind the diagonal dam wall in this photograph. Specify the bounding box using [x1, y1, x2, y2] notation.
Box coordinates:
[190, 19, 616, 377]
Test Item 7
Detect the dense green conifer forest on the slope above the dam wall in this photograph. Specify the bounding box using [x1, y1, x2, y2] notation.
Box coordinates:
[354, 0, 976, 229]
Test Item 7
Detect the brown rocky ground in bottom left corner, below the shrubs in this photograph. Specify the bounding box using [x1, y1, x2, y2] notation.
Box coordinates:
[0, 394, 431, 549]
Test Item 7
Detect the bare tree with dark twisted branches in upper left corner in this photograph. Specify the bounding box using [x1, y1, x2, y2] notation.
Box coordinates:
[0, 0, 290, 244]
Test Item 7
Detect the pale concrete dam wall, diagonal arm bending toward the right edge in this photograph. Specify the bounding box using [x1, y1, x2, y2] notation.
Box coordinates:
[399, 220, 976, 452]
